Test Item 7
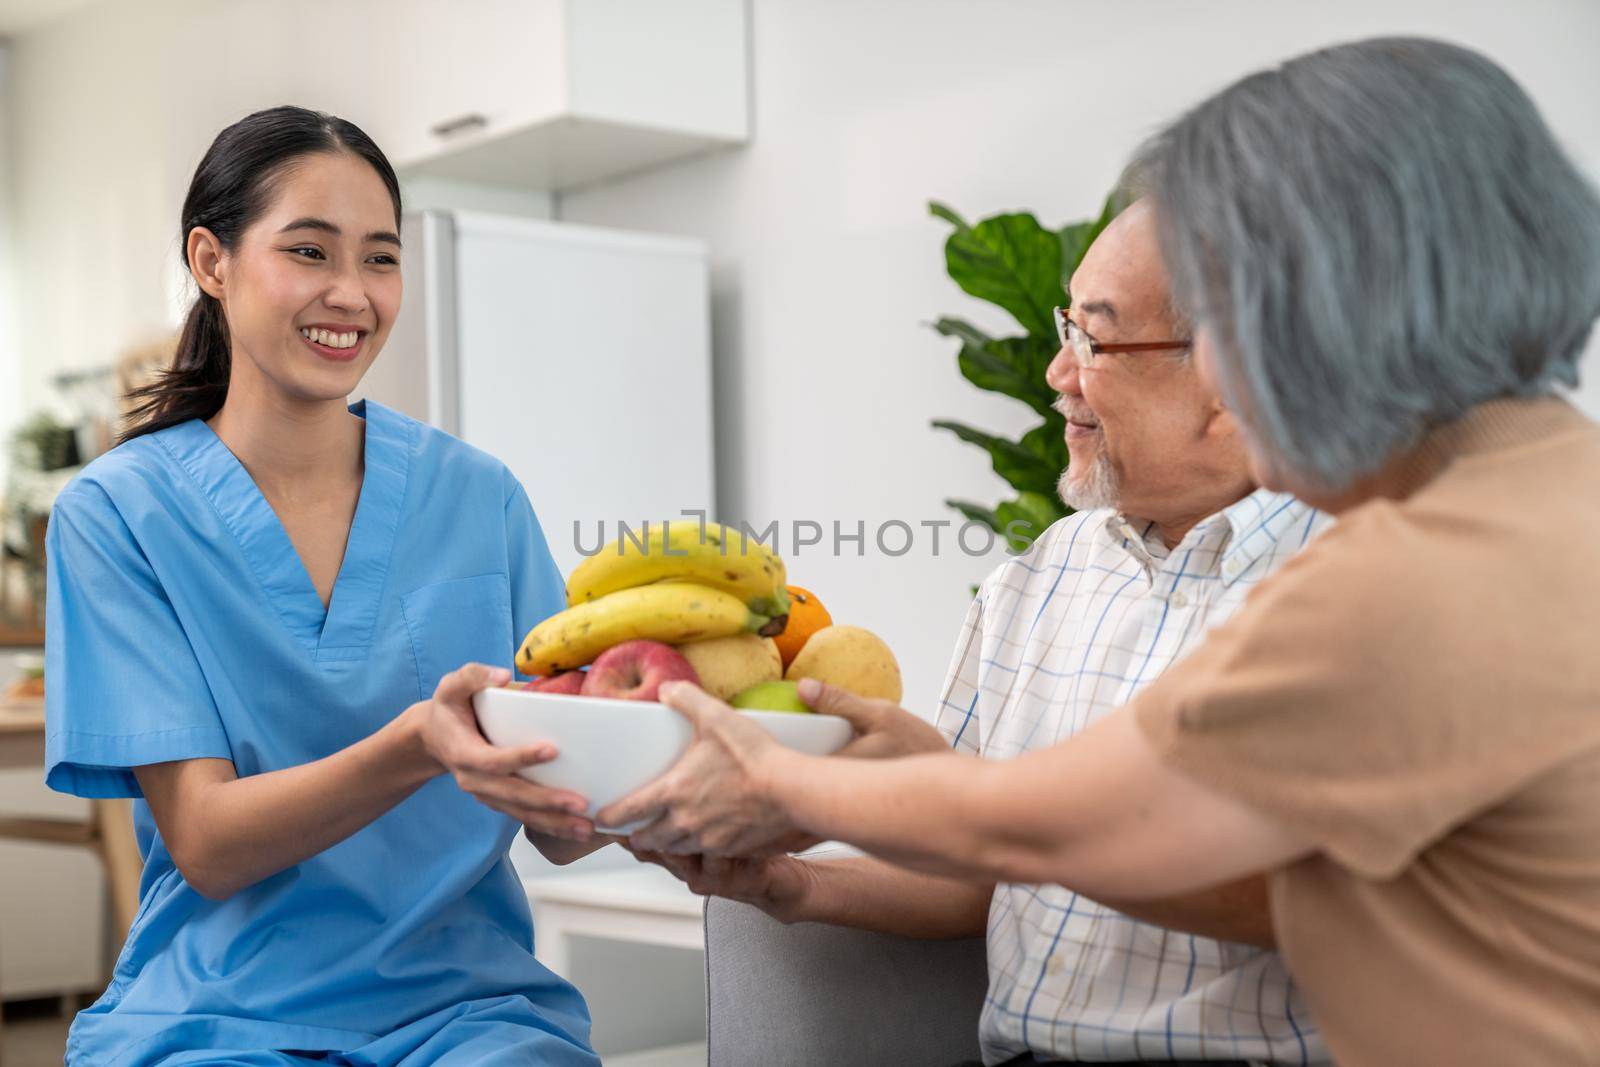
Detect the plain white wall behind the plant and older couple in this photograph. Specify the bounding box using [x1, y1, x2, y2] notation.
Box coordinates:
[557, 0, 1600, 712]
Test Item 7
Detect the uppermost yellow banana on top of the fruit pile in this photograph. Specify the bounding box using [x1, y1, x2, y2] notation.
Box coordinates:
[566, 518, 789, 617]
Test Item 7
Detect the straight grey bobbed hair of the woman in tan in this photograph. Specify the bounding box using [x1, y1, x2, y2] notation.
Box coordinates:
[1130, 38, 1600, 491]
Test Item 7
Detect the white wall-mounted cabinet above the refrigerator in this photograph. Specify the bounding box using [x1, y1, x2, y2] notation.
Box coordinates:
[326, 0, 749, 190]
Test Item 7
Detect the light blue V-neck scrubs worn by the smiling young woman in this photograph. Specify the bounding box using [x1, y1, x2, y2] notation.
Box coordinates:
[45, 402, 598, 1067]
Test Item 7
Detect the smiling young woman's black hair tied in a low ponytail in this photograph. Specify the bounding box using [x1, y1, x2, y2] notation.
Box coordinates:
[122, 107, 400, 442]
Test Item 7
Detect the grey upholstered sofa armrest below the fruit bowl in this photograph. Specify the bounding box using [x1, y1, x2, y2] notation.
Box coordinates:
[706, 897, 989, 1067]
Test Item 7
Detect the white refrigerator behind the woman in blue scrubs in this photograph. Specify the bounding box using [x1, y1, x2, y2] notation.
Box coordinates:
[360, 211, 715, 574]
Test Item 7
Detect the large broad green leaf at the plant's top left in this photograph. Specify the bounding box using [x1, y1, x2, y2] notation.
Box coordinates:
[928, 203, 1062, 334]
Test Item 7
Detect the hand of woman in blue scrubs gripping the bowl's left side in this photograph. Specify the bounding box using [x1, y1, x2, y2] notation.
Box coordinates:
[406, 664, 594, 841]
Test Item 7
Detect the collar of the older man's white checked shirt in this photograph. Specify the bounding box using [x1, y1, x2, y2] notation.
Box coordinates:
[1104, 490, 1312, 587]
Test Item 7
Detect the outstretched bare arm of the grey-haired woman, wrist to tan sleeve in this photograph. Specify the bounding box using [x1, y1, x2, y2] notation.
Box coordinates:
[765, 713, 1310, 901]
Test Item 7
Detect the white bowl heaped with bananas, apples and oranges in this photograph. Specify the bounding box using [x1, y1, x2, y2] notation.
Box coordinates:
[474, 523, 901, 832]
